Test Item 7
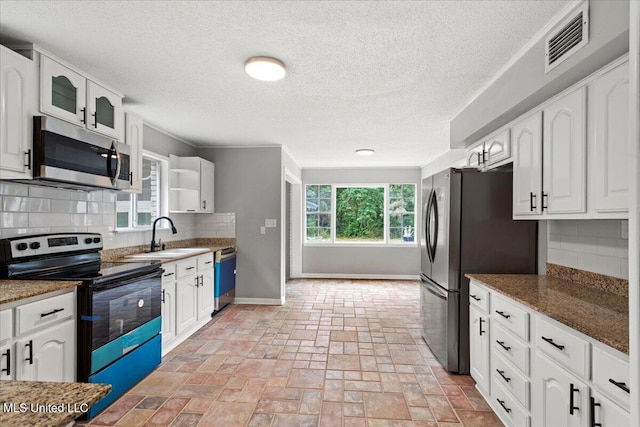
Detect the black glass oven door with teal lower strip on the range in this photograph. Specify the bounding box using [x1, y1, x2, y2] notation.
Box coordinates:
[78, 269, 162, 381]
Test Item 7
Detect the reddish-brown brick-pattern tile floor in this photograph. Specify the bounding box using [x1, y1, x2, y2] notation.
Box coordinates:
[80, 280, 502, 427]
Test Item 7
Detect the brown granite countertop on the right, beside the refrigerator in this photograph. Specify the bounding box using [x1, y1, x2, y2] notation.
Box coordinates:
[466, 274, 629, 354]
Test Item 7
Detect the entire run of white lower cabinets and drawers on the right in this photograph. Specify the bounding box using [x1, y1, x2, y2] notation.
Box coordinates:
[469, 280, 630, 427]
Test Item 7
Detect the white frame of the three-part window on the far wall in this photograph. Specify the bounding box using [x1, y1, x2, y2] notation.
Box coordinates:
[302, 181, 419, 248]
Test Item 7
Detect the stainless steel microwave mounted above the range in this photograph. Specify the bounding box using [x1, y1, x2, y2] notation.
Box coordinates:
[33, 116, 132, 190]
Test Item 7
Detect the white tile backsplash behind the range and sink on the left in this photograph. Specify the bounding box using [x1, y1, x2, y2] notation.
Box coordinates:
[0, 181, 235, 249]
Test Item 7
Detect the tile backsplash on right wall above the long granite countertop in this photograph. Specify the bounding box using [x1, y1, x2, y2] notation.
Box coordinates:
[547, 220, 629, 280]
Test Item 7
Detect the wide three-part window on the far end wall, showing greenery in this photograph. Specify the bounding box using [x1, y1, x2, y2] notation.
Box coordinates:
[306, 184, 416, 244]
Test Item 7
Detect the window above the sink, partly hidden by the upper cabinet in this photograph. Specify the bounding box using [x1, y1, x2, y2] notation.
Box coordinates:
[116, 153, 167, 229]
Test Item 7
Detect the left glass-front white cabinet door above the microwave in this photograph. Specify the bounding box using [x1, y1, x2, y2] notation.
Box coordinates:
[40, 55, 87, 126]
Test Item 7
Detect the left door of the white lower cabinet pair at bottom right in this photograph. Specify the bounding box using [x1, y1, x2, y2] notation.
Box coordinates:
[533, 352, 589, 427]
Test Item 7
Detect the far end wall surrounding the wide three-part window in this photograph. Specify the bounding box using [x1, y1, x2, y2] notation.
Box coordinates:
[302, 168, 422, 278]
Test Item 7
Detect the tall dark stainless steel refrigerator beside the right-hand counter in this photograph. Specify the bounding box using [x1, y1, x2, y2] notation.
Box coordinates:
[420, 166, 537, 374]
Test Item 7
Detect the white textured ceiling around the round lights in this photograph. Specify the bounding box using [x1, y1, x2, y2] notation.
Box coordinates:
[0, 0, 567, 167]
